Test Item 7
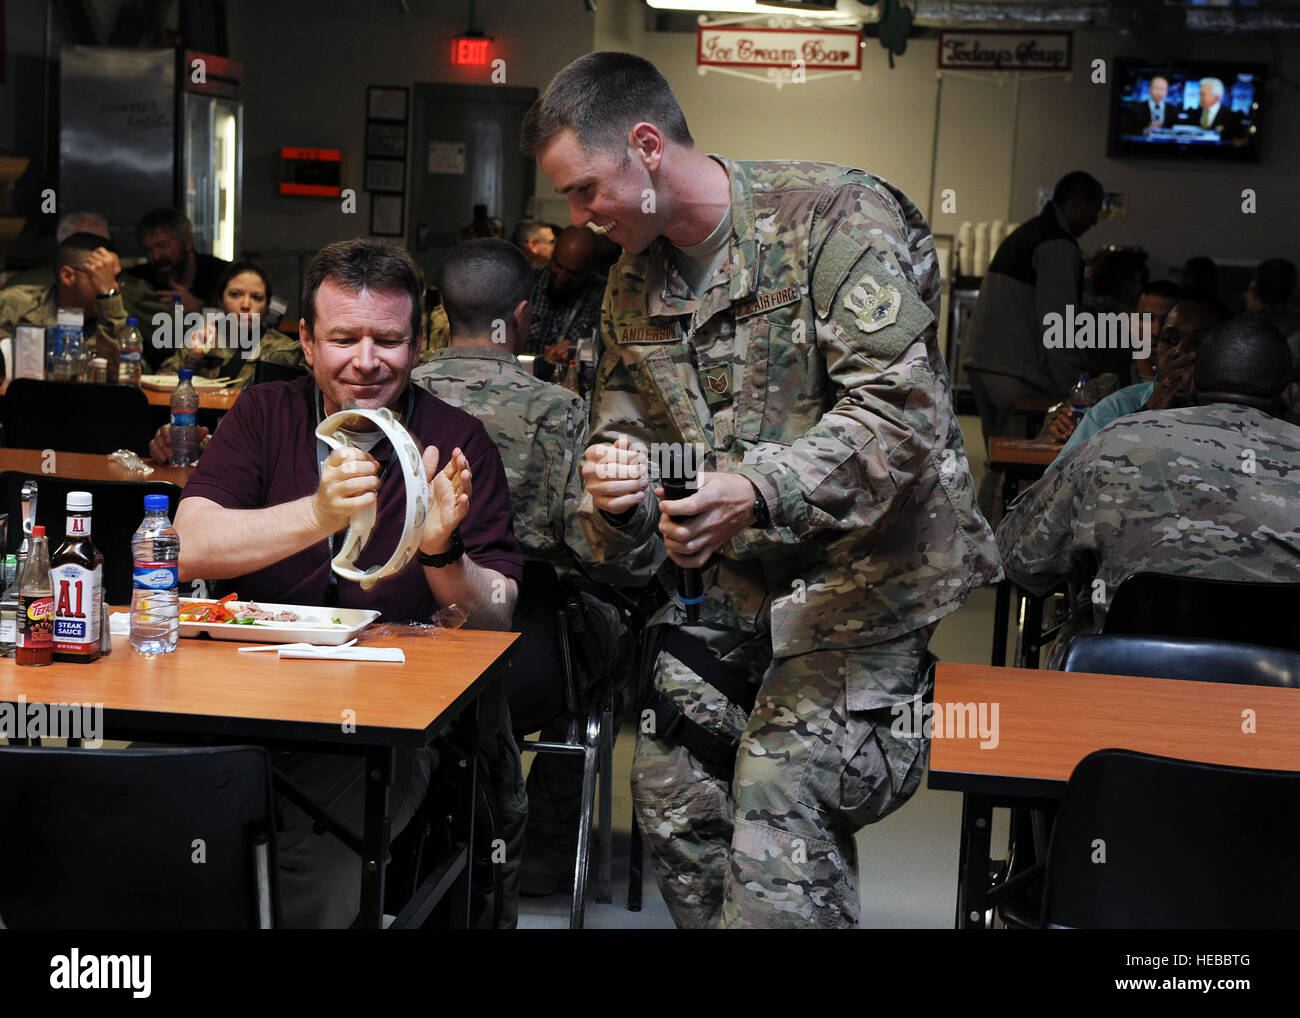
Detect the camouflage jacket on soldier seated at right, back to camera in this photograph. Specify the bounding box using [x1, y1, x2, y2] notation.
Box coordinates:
[997, 403, 1300, 631]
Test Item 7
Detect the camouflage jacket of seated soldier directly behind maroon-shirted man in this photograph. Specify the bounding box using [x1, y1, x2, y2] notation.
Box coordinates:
[411, 346, 590, 563]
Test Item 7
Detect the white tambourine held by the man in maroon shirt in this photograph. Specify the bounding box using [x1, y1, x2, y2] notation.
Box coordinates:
[316, 408, 429, 590]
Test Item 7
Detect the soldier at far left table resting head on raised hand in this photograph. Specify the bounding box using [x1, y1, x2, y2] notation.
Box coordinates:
[0, 233, 126, 378]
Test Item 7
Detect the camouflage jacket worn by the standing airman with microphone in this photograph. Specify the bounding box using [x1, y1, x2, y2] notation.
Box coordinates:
[582, 160, 1001, 657]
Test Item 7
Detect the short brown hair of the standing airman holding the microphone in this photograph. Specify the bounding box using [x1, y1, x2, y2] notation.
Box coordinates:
[519, 52, 694, 163]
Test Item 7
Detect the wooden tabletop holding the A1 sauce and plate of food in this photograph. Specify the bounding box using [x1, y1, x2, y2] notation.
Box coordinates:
[0, 629, 519, 745]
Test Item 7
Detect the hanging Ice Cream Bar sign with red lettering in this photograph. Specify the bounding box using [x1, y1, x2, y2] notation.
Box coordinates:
[696, 25, 862, 70]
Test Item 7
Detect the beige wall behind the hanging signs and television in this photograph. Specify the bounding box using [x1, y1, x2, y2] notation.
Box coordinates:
[590, 0, 1300, 274]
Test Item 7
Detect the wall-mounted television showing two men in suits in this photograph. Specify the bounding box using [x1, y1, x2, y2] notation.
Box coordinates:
[1106, 60, 1264, 161]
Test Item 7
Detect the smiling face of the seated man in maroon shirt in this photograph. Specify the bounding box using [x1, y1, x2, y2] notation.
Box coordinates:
[302, 280, 420, 415]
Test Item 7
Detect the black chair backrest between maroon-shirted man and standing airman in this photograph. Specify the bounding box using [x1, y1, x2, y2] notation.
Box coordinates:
[502, 559, 568, 735]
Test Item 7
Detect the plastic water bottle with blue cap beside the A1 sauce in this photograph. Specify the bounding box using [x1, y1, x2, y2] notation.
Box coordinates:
[131, 495, 181, 654]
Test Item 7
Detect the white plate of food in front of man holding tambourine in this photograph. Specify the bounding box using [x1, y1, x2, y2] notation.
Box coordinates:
[181, 594, 380, 646]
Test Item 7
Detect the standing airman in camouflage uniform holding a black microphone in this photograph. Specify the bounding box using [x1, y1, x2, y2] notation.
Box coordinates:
[523, 53, 1001, 927]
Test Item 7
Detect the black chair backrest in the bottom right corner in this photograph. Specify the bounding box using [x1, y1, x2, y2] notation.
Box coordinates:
[1043, 749, 1300, 928]
